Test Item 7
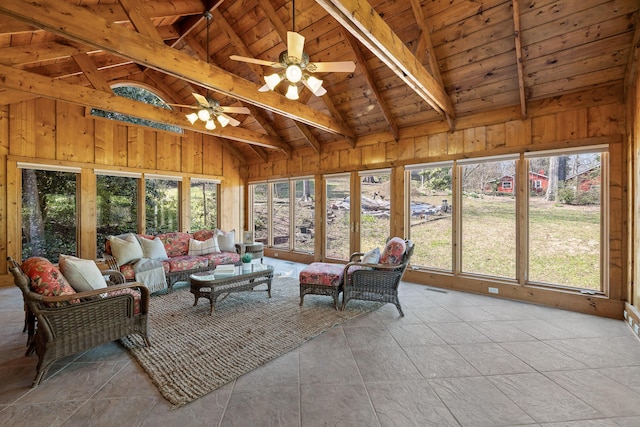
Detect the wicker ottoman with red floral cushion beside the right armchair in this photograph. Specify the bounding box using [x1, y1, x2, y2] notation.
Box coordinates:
[300, 262, 344, 310]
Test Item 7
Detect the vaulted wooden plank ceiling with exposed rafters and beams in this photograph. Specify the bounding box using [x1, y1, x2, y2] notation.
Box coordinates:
[0, 0, 640, 161]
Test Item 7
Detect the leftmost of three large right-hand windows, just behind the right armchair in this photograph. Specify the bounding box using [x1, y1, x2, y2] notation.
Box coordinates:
[405, 162, 454, 271]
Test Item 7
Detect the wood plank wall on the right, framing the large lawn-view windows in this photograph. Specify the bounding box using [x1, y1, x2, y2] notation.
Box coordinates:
[247, 85, 637, 318]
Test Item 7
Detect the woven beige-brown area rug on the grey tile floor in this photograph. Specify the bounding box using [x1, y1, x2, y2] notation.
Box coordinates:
[122, 277, 380, 406]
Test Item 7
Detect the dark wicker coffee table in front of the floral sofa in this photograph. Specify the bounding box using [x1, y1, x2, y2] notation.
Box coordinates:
[189, 264, 273, 314]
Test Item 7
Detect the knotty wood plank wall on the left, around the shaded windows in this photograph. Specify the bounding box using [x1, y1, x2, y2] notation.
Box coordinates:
[0, 99, 245, 285]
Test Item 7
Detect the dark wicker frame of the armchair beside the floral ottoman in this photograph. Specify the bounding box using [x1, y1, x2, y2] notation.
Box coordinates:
[342, 240, 414, 316]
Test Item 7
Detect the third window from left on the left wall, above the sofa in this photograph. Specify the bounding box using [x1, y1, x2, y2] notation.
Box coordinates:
[145, 175, 180, 234]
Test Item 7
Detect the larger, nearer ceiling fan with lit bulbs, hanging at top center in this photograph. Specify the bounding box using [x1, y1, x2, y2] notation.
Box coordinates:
[230, 0, 356, 100]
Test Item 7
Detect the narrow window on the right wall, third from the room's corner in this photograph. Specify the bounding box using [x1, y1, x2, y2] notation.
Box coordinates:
[293, 178, 315, 253]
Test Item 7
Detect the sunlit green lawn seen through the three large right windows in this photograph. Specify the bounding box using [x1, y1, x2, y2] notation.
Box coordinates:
[411, 198, 600, 290]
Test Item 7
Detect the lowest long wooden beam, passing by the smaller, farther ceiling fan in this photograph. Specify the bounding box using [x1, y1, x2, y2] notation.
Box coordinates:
[0, 65, 288, 150]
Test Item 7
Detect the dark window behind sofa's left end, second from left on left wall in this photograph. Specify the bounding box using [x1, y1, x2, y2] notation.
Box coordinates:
[96, 171, 139, 254]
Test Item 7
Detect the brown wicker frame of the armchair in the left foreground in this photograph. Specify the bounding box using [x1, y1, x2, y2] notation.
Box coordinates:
[7, 257, 150, 387]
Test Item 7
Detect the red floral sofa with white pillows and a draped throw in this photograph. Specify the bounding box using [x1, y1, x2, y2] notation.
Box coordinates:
[105, 229, 240, 292]
